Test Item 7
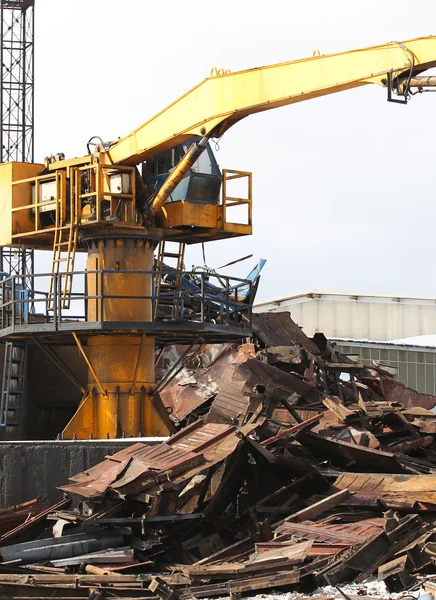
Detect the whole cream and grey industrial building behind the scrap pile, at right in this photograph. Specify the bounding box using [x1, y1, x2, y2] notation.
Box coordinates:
[254, 291, 436, 395]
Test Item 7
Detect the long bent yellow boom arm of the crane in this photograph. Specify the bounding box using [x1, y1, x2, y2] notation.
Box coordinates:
[109, 36, 436, 165]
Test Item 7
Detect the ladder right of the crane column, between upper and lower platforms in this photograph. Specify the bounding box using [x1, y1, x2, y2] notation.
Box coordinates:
[154, 240, 186, 319]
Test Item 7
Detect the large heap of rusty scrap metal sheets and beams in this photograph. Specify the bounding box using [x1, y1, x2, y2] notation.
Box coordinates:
[0, 313, 436, 600]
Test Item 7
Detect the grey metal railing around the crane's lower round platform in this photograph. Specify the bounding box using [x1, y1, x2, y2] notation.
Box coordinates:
[0, 270, 254, 335]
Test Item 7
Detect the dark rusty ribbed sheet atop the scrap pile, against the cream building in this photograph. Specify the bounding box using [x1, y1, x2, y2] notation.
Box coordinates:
[252, 311, 320, 355]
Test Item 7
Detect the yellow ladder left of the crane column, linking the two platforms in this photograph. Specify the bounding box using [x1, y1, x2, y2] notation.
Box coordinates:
[47, 195, 79, 310]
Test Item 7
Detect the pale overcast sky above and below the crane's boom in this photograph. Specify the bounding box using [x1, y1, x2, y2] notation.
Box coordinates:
[35, 0, 436, 299]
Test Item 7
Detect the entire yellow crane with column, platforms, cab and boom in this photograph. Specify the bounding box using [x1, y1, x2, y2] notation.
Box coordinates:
[0, 37, 436, 439]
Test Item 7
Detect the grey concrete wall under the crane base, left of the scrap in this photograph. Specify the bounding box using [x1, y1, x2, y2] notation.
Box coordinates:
[0, 438, 167, 508]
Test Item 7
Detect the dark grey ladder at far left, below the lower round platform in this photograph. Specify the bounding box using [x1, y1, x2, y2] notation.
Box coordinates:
[0, 342, 27, 427]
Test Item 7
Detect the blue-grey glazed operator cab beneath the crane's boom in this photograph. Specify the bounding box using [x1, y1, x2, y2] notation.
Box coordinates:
[142, 137, 222, 204]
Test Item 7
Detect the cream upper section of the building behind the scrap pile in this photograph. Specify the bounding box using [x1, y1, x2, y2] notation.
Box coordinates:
[254, 293, 436, 341]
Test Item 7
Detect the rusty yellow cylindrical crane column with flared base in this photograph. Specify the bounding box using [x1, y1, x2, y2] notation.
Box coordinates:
[63, 236, 168, 439]
